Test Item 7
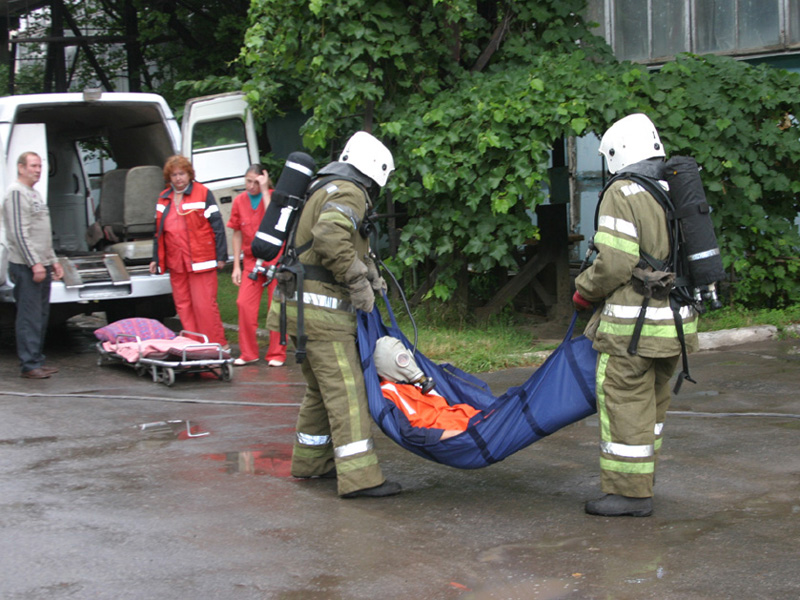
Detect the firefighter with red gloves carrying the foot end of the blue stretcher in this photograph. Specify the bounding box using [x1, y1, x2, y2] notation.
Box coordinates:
[573, 114, 697, 517]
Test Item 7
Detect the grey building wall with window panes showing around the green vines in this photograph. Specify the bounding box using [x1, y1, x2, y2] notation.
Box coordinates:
[571, 0, 800, 256]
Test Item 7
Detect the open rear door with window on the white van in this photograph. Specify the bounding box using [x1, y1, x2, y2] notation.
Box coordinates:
[181, 92, 260, 253]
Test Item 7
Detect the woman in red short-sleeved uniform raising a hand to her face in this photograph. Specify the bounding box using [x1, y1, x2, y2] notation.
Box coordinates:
[228, 165, 286, 367]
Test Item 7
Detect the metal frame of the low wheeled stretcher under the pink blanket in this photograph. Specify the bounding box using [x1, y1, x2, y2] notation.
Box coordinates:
[96, 329, 234, 387]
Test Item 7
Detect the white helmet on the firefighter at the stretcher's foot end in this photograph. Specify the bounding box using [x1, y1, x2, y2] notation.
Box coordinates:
[600, 113, 666, 175]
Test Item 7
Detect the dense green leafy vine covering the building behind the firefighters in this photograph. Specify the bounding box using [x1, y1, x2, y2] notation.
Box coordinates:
[234, 0, 800, 306]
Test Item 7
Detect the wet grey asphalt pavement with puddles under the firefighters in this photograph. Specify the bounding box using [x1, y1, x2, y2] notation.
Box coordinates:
[0, 316, 800, 600]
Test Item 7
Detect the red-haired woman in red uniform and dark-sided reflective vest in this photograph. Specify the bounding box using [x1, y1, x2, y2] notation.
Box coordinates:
[150, 156, 229, 350]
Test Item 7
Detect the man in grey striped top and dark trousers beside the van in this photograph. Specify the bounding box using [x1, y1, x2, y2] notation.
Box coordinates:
[3, 152, 64, 379]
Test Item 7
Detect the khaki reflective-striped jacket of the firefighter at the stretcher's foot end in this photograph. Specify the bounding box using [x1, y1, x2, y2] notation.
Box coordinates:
[575, 179, 697, 358]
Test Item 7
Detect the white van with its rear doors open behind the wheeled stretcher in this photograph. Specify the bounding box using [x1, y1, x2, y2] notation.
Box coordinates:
[0, 92, 259, 323]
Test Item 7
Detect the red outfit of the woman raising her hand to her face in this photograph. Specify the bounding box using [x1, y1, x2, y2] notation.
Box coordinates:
[228, 192, 286, 363]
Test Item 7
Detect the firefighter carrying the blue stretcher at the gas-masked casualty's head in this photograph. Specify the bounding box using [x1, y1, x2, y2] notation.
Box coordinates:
[267, 131, 401, 498]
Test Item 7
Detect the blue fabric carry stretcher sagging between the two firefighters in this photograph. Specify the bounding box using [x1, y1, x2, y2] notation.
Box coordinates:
[358, 295, 597, 469]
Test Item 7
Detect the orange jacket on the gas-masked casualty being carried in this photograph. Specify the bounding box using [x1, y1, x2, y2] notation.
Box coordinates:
[381, 380, 481, 431]
